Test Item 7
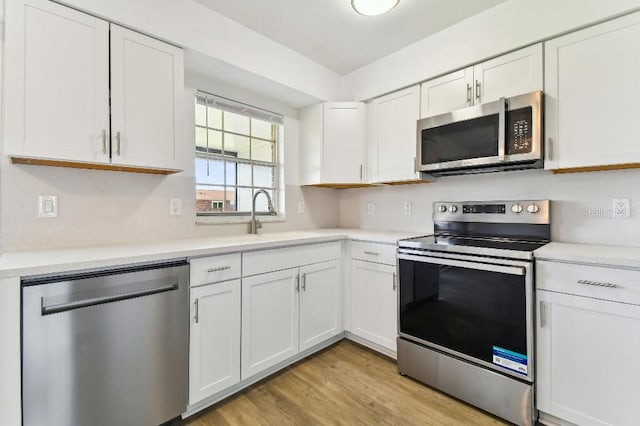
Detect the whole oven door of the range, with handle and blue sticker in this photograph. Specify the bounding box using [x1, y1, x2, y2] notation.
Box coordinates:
[398, 250, 534, 382]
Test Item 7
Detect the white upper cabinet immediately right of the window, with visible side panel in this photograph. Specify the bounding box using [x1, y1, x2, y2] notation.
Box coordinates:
[300, 102, 367, 185]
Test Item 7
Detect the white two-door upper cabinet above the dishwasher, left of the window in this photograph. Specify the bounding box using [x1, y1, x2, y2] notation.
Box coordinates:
[3, 0, 184, 171]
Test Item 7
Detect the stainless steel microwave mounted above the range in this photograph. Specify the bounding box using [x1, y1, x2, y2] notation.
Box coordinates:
[416, 91, 544, 176]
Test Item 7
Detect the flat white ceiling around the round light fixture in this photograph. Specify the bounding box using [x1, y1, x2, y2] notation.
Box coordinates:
[196, 0, 505, 75]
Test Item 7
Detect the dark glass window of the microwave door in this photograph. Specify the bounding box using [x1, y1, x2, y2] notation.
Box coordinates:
[421, 114, 500, 165]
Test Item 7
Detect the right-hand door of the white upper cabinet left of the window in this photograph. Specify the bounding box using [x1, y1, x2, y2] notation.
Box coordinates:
[111, 24, 184, 169]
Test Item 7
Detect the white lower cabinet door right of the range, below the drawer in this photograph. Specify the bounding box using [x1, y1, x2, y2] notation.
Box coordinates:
[536, 290, 640, 426]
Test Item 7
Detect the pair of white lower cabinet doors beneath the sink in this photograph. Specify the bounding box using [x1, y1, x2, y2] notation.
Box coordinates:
[242, 260, 342, 380]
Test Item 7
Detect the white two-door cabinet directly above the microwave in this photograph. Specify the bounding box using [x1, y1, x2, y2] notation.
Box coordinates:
[420, 44, 543, 118]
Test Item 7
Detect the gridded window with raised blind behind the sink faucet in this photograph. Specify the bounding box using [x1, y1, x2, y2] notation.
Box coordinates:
[195, 92, 282, 216]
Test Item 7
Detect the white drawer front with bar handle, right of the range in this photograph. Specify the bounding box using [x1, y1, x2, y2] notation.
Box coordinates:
[536, 261, 640, 305]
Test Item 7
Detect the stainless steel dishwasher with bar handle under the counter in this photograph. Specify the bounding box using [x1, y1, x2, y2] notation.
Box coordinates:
[22, 260, 189, 426]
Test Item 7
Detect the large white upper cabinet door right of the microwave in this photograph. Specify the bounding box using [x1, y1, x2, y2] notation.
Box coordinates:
[545, 13, 640, 169]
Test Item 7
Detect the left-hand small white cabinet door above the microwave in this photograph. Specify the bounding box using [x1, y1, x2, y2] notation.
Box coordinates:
[420, 67, 473, 118]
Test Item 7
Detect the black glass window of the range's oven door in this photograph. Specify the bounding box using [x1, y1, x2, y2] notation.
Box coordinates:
[399, 259, 529, 376]
